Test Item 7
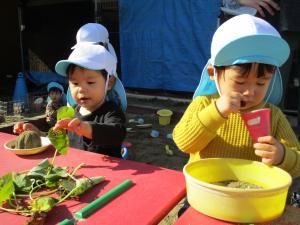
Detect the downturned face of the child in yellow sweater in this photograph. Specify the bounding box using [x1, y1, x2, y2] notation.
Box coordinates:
[218, 63, 273, 109]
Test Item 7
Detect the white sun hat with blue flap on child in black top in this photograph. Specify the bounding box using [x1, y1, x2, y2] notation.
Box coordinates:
[55, 43, 127, 111]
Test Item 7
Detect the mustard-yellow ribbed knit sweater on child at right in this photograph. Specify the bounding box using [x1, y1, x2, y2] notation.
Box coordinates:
[173, 95, 300, 177]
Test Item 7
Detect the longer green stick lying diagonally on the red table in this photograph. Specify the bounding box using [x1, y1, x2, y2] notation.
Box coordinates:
[75, 180, 133, 219]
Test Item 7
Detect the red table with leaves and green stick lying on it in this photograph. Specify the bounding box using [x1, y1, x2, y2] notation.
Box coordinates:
[0, 132, 185, 225]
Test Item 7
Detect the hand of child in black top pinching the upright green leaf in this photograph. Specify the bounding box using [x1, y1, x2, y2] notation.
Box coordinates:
[53, 118, 92, 139]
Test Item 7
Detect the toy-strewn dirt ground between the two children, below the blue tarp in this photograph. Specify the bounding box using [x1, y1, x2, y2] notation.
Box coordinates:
[125, 96, 188, 170]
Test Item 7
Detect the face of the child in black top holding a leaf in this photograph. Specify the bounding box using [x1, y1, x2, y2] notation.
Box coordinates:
[69, 67, 106, 112]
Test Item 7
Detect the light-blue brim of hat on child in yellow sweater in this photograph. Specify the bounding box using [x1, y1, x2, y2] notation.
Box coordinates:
[212, 35, 290, 67]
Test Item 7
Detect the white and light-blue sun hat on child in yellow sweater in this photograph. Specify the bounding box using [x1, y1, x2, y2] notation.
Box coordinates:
[193, 14, 290, 105]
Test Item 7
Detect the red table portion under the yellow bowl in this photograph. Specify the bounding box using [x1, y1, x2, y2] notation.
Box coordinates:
[174, 201, 300, 225]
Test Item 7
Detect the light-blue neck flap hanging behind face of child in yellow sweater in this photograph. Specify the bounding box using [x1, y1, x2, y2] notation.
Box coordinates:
[193, 61, 282, 105]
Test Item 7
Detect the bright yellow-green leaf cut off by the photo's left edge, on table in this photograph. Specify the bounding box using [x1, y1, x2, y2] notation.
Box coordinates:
[0, 173, 15, 205]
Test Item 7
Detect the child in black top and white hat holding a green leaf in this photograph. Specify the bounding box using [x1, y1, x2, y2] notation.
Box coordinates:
[14, 43, 126, 158]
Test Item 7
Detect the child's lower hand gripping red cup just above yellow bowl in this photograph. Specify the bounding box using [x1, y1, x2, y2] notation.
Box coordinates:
[254, 136, 285, 165]
